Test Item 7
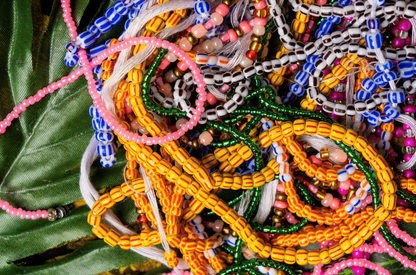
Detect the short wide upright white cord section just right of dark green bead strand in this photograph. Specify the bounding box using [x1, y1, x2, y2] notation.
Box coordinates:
[254, 180, 279, 224]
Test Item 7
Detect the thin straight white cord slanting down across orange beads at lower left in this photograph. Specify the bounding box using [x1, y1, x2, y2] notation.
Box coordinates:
[140, 165, 180, 274]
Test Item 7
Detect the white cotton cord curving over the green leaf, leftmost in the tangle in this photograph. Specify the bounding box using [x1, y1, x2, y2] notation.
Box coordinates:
[79, 135, 189, 274]
